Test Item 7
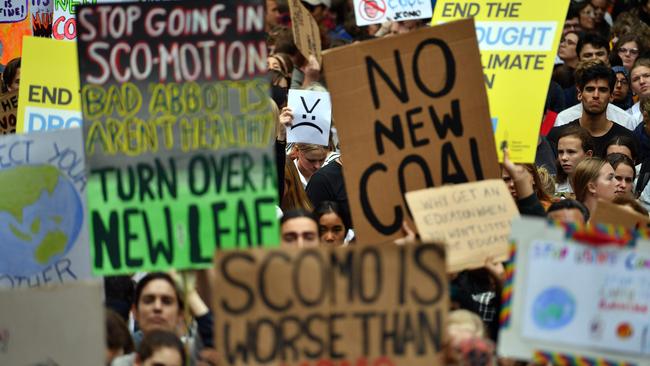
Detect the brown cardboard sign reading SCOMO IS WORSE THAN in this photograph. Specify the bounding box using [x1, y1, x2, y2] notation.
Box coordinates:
[213, 244, 449, 366]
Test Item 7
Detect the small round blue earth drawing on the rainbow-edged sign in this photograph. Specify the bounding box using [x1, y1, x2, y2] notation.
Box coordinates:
[533, 287, 576, 330]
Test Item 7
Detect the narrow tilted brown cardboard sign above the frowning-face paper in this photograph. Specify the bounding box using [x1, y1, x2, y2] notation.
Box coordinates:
[287, 0, 322, 64]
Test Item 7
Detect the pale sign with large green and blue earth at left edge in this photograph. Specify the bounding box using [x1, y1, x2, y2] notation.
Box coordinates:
[0, 128, 91, 287]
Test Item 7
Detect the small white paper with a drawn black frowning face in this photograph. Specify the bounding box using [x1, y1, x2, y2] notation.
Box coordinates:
[287, 89, 332, 146]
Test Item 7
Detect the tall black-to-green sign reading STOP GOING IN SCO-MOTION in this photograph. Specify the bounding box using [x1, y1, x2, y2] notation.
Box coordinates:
[77, 0, 279, 274]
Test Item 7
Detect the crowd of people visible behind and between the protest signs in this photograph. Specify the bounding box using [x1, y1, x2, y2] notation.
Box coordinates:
[1, 0, 650, 366]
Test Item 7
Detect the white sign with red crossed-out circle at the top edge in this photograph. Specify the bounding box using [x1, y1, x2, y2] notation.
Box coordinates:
[353, 0, 433, 26]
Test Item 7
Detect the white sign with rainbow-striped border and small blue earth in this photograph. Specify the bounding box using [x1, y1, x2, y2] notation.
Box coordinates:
[498, 218, 650, 365]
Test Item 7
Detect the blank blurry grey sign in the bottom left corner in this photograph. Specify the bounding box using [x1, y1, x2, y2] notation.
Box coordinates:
[0, 283, 106, 366]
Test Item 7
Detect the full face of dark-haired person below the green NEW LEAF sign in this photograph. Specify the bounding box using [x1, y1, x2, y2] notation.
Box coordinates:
[135, 279, 182, 333]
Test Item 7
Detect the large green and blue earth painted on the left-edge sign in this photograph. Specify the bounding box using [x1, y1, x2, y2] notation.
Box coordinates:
[0, 165, 83, 276]
